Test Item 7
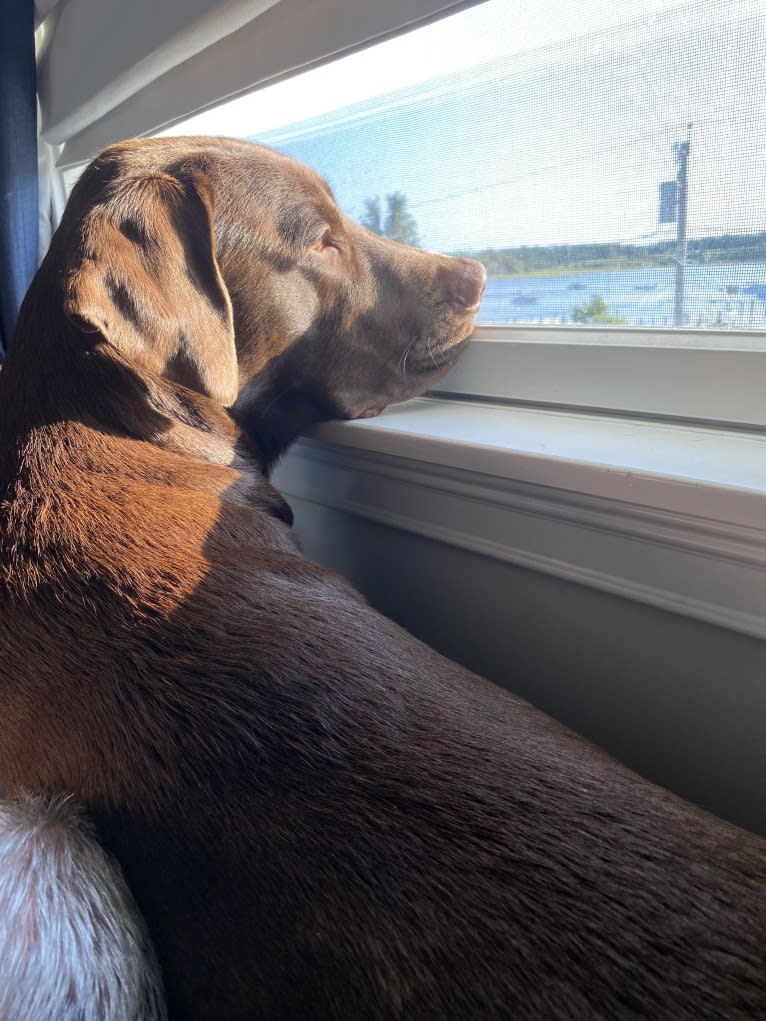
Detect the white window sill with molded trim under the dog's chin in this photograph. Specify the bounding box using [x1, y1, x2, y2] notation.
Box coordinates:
[275, 397, 766, 638]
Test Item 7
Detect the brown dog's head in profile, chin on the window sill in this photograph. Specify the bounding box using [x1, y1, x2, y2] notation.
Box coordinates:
[52, 139, 486, 459]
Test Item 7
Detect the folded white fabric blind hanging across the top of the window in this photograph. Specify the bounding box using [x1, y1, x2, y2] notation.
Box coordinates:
[38, 0, 476, 166]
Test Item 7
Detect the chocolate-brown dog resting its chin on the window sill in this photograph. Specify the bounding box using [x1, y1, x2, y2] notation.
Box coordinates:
[0, 139, 766, 1021]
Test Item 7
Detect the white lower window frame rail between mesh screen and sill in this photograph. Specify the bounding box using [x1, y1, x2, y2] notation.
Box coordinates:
[438, 326, 766, 430]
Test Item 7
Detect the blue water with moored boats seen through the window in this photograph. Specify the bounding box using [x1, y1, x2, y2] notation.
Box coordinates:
[478, 262, 766, 330]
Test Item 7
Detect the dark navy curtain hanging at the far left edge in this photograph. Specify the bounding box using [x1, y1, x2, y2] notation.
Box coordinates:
[0, 0, 38, 357]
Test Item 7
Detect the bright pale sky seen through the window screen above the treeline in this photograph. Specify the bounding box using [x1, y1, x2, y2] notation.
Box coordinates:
[165, 0, 766, 251]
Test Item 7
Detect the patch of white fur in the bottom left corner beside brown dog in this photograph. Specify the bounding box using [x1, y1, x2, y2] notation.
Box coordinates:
[0, 796, 165, 1021]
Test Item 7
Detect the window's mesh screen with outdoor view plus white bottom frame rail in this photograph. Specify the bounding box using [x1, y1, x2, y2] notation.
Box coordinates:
[163, 0, 766, 426]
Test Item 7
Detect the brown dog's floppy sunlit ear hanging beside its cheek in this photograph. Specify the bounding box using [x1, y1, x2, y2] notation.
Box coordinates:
[64, 173, 238, 405]
